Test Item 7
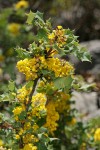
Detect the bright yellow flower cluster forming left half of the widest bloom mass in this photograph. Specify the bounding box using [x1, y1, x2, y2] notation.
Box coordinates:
[17, 58, 39, 80]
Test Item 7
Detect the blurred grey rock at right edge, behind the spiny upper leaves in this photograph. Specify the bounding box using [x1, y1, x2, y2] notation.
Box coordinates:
[70, 40, 100, 76]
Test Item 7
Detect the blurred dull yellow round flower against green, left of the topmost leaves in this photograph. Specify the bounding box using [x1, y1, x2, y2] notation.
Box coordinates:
[7, 23, 21, 36]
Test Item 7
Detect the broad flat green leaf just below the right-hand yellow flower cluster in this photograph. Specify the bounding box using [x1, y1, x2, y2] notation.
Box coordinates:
[54, 76, 73, 90]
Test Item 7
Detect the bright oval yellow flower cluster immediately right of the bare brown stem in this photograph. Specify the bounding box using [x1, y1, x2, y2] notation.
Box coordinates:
[31, 93, 47, 117]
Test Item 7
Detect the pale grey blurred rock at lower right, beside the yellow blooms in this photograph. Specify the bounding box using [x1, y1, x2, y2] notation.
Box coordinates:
[72, 91, 97, 116]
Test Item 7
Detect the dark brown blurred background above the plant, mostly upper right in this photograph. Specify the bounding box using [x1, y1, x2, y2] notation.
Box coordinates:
[0, 0, 100, 41]
